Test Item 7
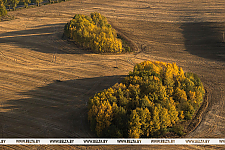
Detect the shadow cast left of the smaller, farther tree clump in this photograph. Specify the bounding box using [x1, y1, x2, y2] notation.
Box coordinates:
[0, 23, 88, 54]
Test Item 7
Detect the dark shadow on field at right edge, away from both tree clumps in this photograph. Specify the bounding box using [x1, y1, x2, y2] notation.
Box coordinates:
[181, 22, 225, 62]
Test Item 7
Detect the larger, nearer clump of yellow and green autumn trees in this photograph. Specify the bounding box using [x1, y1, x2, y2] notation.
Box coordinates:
[88, 61, 205, 138]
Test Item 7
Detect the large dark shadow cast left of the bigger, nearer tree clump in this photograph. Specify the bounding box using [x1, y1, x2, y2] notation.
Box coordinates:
[0, 76, 124, 138]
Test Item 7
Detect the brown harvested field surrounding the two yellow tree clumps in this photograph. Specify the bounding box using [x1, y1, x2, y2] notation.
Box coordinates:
[0, 0, 225, 149]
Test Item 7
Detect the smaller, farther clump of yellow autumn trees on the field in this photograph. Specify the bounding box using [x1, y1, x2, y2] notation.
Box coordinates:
[64, 12, 130, 53]
